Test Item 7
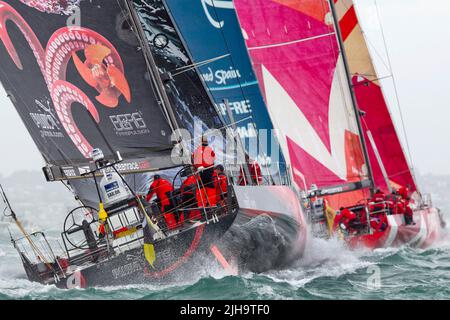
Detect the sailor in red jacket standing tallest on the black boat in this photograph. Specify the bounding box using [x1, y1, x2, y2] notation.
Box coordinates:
[192, 136, 216, 206]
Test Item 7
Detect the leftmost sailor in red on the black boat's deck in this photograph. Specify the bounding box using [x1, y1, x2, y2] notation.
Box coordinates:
[145, 174, 177, 229]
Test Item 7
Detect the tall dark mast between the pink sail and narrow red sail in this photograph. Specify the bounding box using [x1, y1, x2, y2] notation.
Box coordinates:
[328, 0, 375, 194]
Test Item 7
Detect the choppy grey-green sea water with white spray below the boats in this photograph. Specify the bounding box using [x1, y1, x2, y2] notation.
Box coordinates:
[0, 215, 450, 299]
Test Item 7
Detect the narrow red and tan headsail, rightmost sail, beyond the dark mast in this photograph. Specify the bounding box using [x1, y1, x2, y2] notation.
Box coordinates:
[334, 0, 417, 192]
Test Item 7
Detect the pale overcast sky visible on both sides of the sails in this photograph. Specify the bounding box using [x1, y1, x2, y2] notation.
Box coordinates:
[0, 0, 450, 174]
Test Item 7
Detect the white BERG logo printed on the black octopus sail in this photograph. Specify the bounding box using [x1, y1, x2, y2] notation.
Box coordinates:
[109, 112, 150, 136]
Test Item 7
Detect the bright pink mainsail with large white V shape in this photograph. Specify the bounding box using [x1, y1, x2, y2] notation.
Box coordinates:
[235, 0, 370, 205]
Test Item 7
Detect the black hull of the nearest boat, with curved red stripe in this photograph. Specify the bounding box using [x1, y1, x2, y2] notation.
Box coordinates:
[56, 212, 237, 289]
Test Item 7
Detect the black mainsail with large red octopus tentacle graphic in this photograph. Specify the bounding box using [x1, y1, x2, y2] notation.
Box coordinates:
[0, 0, 177, 179]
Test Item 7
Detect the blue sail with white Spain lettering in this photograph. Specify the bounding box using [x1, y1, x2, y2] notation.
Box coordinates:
[166, 0, 273, 162]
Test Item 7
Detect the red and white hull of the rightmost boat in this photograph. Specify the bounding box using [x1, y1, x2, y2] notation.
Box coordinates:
[346, 208, 445, 249]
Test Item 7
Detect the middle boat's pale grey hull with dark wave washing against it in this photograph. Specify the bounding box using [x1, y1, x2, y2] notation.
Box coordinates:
[218, 186, 308, 272]
